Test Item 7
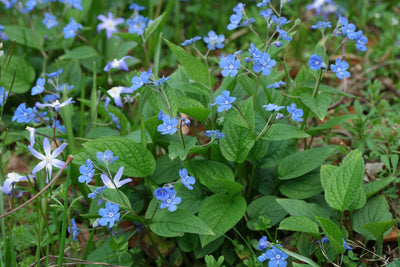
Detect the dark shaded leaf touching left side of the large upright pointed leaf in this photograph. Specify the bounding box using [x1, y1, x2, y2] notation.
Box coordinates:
[279, 169, 324, 199]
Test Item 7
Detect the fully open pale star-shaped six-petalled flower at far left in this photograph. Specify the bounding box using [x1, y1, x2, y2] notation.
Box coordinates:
[28, 137, 67, 183]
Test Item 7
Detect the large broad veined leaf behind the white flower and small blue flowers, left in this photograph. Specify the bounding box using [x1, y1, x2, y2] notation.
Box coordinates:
[73, 136, 156, 177]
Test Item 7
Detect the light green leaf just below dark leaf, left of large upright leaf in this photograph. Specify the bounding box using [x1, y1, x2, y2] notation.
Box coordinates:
[276, 198, 331, 222]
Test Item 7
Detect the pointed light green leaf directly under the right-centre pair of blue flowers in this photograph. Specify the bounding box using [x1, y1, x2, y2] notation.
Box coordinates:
[262, 123, 310, 141]
